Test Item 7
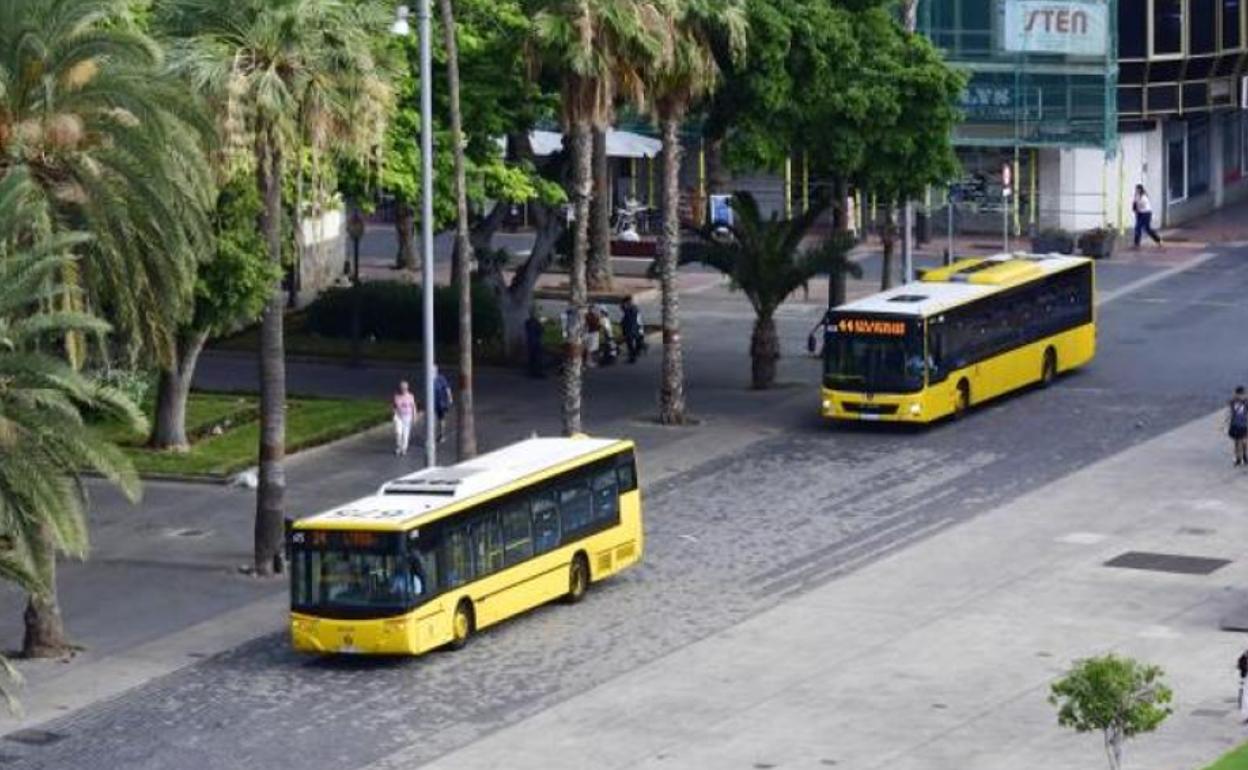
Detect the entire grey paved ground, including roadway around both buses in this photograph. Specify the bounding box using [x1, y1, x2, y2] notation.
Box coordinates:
[0, 207, 1248, 770]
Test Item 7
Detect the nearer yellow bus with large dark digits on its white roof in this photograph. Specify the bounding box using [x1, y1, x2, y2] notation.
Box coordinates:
[288, 437, 644, 655]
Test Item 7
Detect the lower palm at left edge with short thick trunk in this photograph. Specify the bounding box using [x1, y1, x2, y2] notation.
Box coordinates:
[0, 166, 145, 665]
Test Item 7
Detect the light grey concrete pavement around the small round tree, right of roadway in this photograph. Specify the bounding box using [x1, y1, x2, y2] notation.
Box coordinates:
[409, 417, 1248, 770]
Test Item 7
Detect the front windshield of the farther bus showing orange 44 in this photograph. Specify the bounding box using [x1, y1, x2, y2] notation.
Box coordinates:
[824, 313, 925, 393]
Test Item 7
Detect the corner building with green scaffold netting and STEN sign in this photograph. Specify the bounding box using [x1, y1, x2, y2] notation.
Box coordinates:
[919, 0, 1248, 235]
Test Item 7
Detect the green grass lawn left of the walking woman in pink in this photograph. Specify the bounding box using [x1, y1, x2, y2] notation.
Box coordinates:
[99, 393, 389, 478]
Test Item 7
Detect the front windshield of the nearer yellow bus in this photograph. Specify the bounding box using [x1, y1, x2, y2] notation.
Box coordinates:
[291, 532, 423, 618]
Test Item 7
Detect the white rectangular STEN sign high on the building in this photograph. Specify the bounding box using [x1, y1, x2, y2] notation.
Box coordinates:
[1002, 0, 1109, 56]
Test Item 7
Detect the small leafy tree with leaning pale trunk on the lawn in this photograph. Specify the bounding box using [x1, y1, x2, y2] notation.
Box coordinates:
[147, 173, 281, 452]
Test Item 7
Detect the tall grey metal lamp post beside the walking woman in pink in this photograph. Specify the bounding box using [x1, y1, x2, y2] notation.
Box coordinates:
[391, 0, 438, 467]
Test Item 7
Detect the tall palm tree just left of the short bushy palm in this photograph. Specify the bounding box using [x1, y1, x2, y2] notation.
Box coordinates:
[649, 0, 746, 424]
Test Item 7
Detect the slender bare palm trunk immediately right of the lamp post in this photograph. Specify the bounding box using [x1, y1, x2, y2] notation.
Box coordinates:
[438, 0, 477, 461]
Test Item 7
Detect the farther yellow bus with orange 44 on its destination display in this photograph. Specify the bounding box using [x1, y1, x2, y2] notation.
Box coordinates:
[821, 255, 1096, 423]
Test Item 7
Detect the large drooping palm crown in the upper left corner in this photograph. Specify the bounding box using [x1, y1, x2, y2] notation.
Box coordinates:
[0, 0, 213, 364]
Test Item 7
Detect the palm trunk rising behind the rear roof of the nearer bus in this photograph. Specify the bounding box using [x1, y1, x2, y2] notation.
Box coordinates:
[563, 121, 593, 436]
